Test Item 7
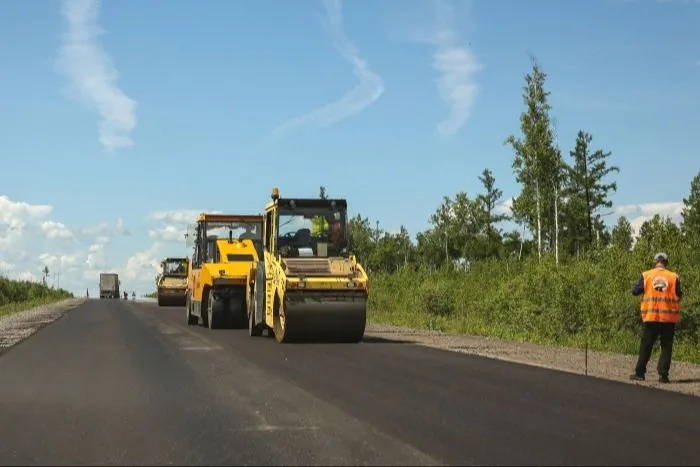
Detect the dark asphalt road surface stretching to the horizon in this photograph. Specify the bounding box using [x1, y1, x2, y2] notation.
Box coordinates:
[0, 300, 700, 465]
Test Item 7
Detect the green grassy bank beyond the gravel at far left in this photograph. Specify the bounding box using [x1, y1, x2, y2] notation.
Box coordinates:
[0, 277, 73, 316]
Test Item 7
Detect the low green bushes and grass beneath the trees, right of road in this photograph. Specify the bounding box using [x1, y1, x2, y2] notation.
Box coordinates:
[369, 250, 700, 363]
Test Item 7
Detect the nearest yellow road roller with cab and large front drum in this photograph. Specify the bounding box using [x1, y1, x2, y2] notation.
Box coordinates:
[247, 188, 368, 343]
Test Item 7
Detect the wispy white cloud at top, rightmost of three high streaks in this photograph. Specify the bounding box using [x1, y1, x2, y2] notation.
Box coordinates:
[431, 2, 483, 137]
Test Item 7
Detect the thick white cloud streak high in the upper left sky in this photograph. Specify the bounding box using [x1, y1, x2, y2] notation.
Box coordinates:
[57, 0, 137, 152]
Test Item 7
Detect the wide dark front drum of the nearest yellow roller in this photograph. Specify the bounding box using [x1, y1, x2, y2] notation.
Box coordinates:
[275, 291, 367, 343]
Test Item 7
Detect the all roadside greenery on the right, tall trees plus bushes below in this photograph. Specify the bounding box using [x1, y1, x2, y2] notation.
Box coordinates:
[334, 58, 700, 363]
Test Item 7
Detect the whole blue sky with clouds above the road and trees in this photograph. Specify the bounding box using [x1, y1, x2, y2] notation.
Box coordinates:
[0, 0, 700, 293]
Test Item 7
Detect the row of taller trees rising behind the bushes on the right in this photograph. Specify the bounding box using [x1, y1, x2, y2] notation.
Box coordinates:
[344, 58, 700, 272]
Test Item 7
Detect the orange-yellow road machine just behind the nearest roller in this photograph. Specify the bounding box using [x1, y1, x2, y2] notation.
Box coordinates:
[185, 213, 263, 329]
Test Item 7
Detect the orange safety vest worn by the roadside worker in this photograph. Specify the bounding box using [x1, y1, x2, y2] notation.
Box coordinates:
[640, 268, 681, 323]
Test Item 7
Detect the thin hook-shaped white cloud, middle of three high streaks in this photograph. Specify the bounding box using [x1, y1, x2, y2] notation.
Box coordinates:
[272, 0, 384, 138]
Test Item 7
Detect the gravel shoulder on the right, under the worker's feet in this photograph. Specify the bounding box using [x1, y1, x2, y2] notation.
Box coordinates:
[365, 323, 700, 396]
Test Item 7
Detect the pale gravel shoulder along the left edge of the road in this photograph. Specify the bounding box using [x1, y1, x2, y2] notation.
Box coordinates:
[0, 298, 87, 355]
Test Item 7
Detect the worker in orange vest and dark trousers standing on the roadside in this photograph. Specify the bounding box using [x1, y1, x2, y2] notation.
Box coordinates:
[630, 253, 683, 383]
